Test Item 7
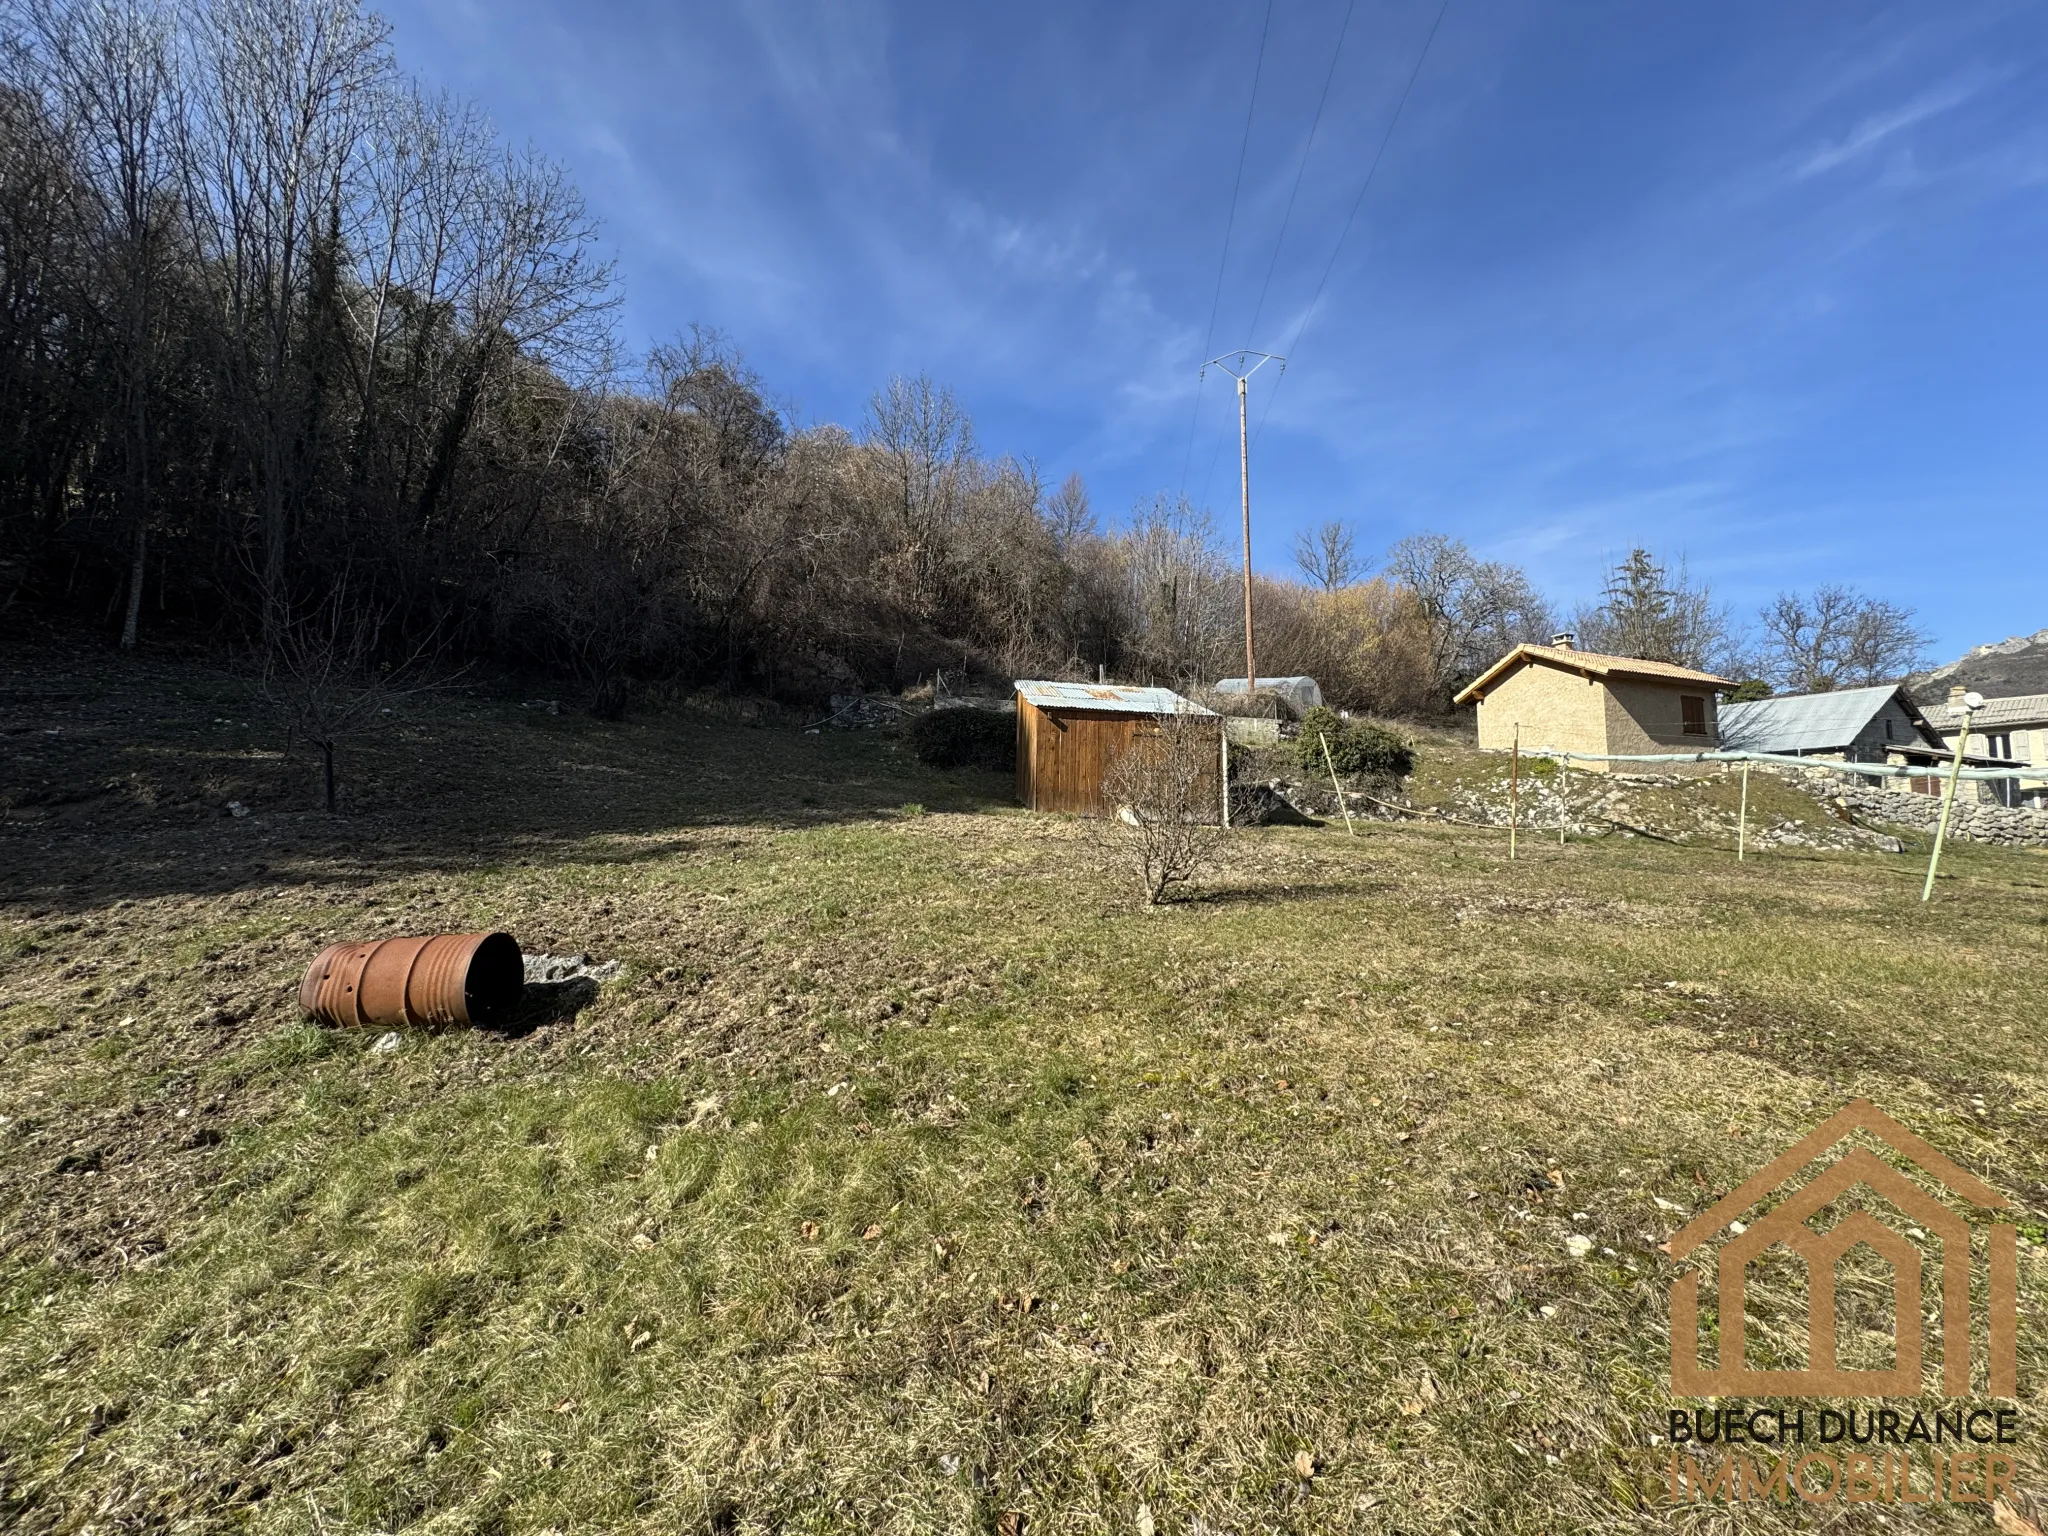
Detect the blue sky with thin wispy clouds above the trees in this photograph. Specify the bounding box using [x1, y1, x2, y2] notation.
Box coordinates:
[385, 0, 2048, 657]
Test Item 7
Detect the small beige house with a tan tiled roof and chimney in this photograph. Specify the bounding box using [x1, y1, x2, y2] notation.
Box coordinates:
[1456, 637, 1735, 772]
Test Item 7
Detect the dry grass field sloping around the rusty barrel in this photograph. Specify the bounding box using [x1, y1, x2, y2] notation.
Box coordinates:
[0, 649, 2048, 1536]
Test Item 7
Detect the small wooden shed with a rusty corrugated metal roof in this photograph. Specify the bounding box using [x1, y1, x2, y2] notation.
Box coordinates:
[1018, 682, 1223, 815]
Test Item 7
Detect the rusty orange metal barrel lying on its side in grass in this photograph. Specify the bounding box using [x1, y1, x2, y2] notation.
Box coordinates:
[299, 934, 526, 1028]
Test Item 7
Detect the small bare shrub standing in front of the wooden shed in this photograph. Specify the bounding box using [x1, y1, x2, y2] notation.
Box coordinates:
[1102, 715, 1223, 905]
